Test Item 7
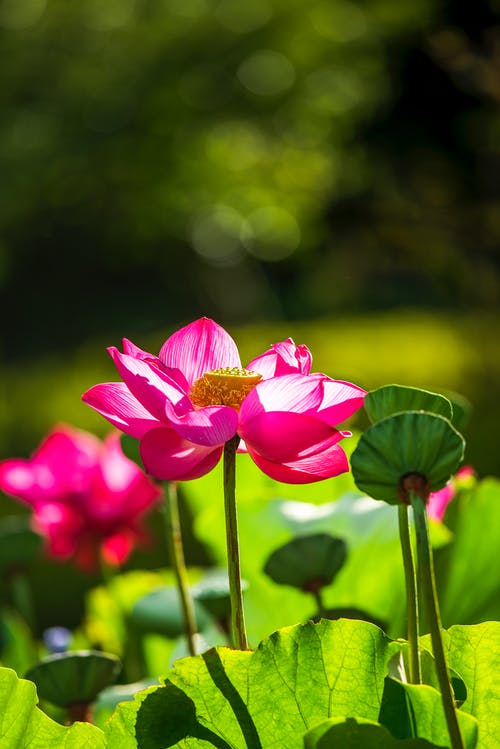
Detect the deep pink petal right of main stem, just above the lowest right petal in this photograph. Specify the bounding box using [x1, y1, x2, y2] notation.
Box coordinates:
[238, 411, 342, 463]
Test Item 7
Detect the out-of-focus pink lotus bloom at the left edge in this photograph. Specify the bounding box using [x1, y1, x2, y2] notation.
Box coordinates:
[0, 425, 160, 571]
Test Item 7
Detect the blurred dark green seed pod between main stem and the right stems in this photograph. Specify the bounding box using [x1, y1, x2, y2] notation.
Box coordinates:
[264, 533, 347, 593]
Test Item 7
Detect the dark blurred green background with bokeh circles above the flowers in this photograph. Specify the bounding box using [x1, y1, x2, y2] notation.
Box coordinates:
[0, 0, 500, 474]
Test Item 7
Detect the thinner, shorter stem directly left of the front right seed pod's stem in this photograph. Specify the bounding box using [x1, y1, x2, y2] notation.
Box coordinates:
[398, 503, 422, 684]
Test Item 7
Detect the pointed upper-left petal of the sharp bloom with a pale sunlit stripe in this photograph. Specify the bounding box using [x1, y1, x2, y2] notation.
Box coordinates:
[108, 347, 186, 421]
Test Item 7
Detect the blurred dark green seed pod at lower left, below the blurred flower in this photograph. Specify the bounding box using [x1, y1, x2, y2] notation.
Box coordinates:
[24, 650, 121, 707]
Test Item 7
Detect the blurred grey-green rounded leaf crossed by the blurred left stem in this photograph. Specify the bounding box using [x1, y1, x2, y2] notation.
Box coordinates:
[130, 586, 209, 638]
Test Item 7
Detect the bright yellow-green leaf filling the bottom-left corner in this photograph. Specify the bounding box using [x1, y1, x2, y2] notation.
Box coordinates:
[0, 668, 106, 749]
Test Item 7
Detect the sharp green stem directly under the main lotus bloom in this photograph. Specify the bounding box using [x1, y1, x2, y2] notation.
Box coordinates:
[224, 435, 248, 650]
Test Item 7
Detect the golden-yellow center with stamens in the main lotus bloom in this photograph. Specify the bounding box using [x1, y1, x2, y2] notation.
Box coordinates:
[189, 367, 262, 411]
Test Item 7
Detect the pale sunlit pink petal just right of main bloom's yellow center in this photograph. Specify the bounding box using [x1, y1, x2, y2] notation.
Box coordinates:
[240, 374, 324, 423]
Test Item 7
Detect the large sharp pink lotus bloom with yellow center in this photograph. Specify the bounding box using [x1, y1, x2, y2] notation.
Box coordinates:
[83, 318, 365, 483]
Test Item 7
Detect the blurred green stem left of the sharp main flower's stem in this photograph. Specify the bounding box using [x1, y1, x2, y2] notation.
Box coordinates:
[165, 481, 197, 655]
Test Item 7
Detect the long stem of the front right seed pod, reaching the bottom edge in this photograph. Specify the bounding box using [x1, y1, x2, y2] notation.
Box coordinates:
[409, 491, 464, 749]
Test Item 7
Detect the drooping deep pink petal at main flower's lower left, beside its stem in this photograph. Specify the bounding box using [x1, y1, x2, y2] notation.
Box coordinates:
[140, 427, 223, 481]
